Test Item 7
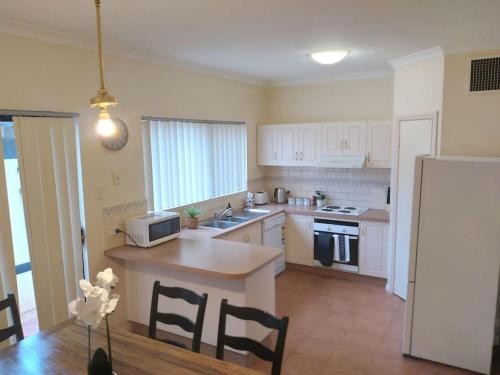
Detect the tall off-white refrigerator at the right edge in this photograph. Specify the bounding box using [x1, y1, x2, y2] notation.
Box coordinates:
[403, 157, 500, 374]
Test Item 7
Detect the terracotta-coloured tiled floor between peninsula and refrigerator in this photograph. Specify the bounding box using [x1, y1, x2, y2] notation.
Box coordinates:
[251, 270, 471, 375]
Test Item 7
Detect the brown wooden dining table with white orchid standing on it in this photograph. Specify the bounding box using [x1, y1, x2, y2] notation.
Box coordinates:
[0, 322, 262, 375]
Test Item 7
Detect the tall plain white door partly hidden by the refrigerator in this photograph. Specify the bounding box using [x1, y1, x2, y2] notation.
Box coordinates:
[394, 117, 436, 300]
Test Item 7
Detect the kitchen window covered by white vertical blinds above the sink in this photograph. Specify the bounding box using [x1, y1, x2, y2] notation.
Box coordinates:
[145, 118, 247, 211]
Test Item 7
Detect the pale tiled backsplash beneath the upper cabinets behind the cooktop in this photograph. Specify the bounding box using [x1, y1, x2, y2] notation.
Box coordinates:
[260, 167, 391, 209]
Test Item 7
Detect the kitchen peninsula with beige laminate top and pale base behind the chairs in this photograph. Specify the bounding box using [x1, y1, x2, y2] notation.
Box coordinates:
[105, 228, 280, 352]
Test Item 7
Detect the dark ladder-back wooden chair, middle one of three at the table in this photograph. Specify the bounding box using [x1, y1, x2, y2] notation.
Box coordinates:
[148, 281, 208, 353]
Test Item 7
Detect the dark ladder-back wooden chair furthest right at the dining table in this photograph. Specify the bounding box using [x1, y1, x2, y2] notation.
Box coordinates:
[216, 299, 288, 375]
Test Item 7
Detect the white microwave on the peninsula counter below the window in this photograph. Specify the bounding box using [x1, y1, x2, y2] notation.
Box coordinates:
[126, 211, 181, 247]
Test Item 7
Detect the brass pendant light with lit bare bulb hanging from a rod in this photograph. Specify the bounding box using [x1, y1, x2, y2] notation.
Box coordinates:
[90, 0, 118, 137]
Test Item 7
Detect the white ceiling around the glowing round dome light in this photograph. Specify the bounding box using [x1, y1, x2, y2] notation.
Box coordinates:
[0, 0, 500, 85]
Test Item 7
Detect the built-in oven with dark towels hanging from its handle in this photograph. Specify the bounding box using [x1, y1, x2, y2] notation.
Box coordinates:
[314, 219, 359, 272]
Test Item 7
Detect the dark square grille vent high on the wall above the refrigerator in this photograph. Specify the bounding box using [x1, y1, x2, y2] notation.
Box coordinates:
[469, 56, 500, 93]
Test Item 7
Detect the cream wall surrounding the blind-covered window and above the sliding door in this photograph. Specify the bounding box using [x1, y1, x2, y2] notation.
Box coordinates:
[0, 34, 264, 290]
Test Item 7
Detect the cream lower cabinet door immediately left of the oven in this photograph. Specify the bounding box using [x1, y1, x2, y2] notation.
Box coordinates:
[285, 215, 314, 266]
